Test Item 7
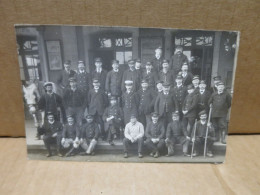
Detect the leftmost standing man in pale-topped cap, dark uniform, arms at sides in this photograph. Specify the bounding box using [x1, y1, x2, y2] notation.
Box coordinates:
[38, 82, 66, 125]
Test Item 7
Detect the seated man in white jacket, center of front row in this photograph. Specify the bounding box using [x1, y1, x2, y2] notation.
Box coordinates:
[123, 114, 144, 158]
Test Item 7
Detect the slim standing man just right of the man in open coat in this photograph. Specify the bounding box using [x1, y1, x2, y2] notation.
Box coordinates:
[173, 75, 187, 120]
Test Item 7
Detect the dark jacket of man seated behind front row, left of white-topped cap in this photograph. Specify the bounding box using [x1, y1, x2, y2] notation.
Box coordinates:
[103, 105, 124, 131]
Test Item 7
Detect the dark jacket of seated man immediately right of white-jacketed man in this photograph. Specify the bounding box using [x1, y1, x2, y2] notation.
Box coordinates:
[145, 121, 165, 139]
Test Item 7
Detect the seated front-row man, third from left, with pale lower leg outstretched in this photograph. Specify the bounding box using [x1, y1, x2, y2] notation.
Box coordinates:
[80, 115, 99, 155]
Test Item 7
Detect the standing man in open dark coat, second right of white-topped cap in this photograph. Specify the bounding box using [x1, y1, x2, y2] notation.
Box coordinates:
[154, 83, 178, 128]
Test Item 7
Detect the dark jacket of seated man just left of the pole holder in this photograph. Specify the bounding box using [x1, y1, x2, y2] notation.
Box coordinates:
[166, 121, 187, 139]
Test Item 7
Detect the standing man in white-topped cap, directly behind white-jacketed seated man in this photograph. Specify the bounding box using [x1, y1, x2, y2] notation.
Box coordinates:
[122, 80, 138, 125]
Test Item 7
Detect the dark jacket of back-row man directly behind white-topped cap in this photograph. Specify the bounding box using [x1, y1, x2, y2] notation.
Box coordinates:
[121, 69, 141, 92]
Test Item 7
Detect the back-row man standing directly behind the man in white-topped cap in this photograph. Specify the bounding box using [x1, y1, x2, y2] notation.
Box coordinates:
[121, 60, 141, 92]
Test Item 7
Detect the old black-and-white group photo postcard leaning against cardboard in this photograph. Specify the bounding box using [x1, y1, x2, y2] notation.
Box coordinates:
[15, 25, 239, 163]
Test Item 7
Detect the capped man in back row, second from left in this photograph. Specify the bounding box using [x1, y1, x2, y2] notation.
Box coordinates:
[75, 61, 91, 100]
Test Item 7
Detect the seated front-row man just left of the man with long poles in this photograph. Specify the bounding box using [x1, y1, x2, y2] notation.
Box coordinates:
[165, 112, 190, 156]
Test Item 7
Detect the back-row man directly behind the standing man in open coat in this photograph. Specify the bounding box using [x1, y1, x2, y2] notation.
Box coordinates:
[159, 60, 175, 87]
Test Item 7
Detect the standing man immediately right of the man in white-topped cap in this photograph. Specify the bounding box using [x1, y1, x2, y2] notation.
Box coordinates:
[136, 79, 157, 127]
